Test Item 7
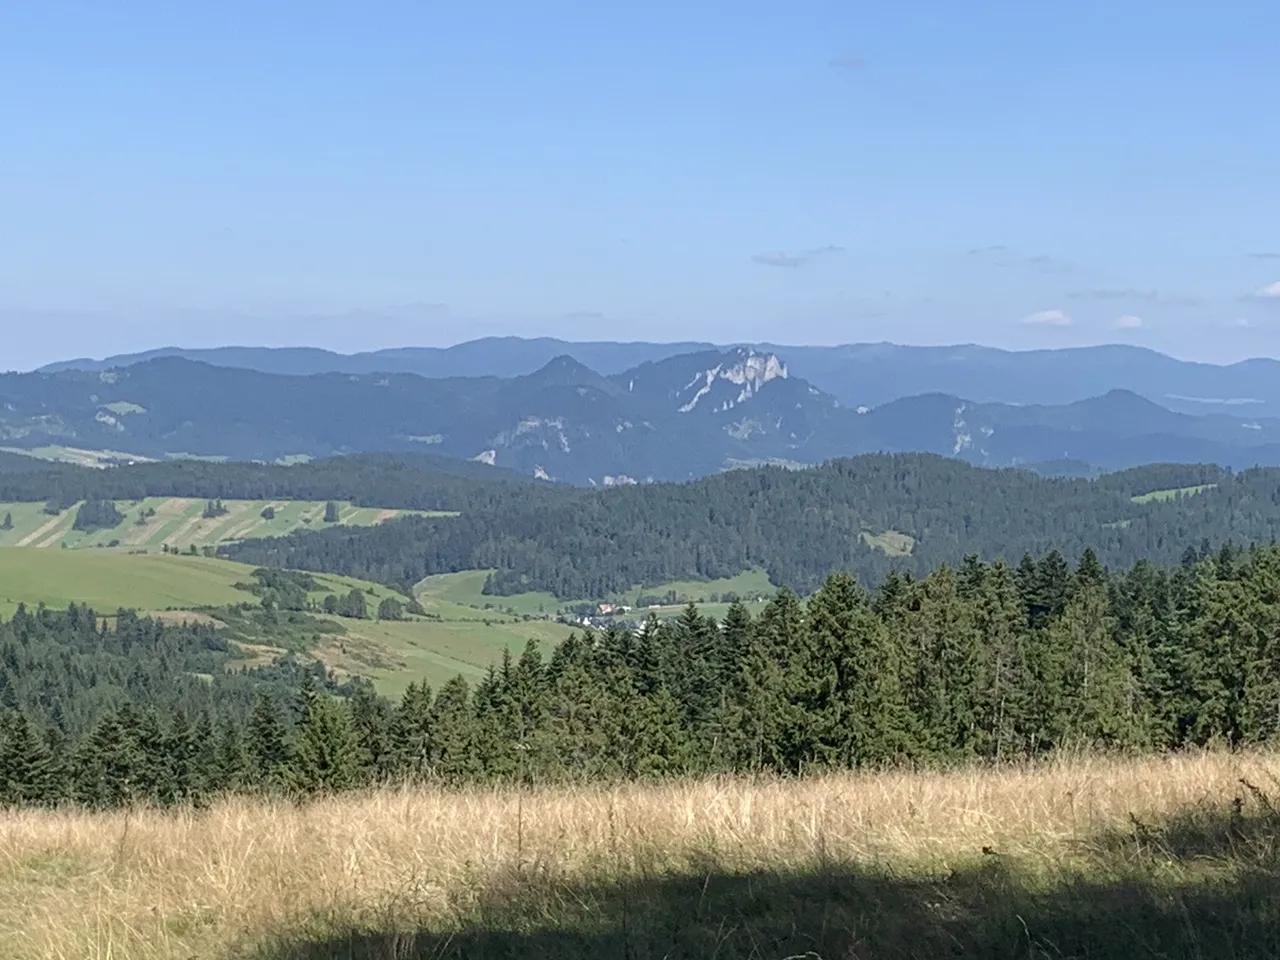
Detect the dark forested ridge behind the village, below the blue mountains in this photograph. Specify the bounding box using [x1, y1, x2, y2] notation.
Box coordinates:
[224, 454, 1280, 599]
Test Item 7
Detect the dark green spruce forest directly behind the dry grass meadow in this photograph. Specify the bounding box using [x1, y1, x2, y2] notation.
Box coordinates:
[0, 547, 1280, 805]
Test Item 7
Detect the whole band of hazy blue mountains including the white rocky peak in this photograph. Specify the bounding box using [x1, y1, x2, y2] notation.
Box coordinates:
[0, 340, 1280, 485]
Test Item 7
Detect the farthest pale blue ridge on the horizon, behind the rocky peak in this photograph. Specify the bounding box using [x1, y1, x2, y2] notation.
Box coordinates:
[35, 337, 1280, 417]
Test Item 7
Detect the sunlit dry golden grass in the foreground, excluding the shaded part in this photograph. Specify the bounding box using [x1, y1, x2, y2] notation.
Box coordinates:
[0, 753, 1280, 960]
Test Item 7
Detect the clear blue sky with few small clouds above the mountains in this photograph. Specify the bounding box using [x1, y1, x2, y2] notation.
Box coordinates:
[0, 0, 1280, 369]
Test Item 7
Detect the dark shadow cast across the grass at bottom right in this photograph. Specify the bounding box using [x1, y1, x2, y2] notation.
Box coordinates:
[247, 804, 1280, 960]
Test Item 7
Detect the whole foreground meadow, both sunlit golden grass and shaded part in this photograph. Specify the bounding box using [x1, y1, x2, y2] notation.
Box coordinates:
[0, 754, 1280, 960]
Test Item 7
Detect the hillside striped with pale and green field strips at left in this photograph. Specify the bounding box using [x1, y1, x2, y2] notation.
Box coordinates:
[0, 497, 442, 550]
